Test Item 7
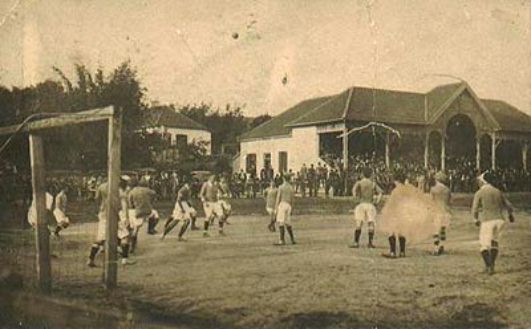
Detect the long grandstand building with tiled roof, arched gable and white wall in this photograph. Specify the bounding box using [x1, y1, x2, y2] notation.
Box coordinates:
[240, 82, 531, 171]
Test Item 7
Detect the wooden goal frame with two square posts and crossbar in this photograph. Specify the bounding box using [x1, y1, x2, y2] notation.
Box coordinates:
[0, 106, 122, 293]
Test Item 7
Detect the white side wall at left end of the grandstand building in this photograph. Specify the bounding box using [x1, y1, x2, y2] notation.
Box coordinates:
[240, 126, 320, 173]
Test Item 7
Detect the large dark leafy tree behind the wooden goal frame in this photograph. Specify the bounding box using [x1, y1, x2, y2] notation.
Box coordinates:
[0, 61, 151, 169]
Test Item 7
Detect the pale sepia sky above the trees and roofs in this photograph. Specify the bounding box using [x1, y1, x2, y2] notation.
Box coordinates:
[0, 0, 531, 116]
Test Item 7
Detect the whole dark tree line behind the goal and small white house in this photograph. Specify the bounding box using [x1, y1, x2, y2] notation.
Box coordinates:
[0, 61, 270, 170]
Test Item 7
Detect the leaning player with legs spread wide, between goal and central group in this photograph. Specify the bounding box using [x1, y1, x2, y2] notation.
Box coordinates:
[160, 180, 197, 241]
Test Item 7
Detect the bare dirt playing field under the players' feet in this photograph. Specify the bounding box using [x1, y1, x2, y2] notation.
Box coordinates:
[0, 200, 531, 328]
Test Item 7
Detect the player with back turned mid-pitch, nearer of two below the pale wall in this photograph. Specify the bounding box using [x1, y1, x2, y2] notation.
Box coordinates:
[275, 175, 296, 246]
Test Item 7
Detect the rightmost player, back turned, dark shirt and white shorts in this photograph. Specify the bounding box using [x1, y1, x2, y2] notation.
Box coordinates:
[472, 172, 514, 275]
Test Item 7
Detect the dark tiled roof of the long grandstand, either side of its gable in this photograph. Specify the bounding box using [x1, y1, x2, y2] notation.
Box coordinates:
[241, 82, 531, 140]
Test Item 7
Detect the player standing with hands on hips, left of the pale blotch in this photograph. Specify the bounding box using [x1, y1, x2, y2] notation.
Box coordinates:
[349, 167, 383, 248]
